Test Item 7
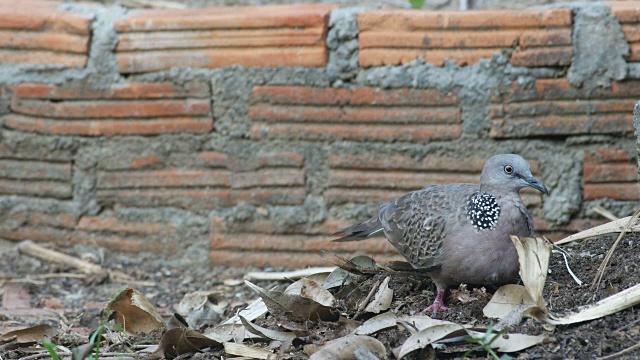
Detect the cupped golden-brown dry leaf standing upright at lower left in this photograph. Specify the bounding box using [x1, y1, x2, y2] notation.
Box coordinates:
[106, 286, 166, 334]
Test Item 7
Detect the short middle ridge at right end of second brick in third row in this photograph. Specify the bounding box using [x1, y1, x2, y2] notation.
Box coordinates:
[230, 169, 304, 189]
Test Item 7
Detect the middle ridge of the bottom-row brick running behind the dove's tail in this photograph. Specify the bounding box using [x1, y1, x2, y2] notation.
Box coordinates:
[210, 233, 394, 254]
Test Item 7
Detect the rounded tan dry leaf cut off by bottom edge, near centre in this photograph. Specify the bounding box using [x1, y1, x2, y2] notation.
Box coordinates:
[309, 335, 387, 360]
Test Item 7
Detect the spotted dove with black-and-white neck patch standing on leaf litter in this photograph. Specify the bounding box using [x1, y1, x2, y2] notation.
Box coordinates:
[334, 154, 548, 314]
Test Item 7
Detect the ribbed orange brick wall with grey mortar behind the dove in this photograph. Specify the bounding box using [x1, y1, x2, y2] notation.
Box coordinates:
[0, 0, 640, 267]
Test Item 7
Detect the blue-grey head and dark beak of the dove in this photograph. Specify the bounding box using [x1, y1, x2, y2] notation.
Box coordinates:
[480, 154, 549, 194]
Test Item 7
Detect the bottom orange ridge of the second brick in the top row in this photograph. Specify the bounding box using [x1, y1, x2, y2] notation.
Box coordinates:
[116, 46, 327, 74]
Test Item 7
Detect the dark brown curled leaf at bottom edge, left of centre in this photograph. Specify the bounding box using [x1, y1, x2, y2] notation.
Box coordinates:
[147, 328, 221, 360]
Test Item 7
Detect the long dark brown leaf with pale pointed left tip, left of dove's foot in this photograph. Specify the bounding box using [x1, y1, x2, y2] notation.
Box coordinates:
[245, 281, 340, 321]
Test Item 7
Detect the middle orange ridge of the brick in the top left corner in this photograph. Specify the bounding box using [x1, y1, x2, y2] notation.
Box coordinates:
[0, 30, 89, 54]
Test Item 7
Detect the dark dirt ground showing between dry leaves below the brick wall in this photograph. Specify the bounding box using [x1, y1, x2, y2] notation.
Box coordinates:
[0, 233, 640, 359]
